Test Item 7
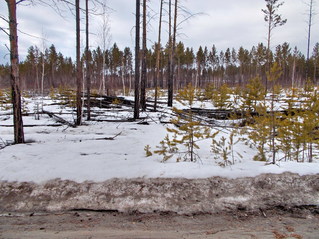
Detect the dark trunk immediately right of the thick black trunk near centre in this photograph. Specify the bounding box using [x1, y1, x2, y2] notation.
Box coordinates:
[141, 0, 147, 111]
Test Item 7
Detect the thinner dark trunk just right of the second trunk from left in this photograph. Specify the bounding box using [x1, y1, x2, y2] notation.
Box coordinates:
[85, 0, 91, 120]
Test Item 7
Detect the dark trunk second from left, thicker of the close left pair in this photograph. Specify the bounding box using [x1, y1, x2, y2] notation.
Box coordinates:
[75, 0, 82, 125]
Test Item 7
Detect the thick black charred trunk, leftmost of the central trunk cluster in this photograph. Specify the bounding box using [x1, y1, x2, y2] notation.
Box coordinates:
[134, 0, 140, 119]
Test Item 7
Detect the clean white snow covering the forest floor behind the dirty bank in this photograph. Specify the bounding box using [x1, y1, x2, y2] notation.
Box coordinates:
[0, 95, 319, 183]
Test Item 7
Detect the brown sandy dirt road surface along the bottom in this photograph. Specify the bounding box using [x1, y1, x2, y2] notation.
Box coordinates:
[0, 211, 319, 239]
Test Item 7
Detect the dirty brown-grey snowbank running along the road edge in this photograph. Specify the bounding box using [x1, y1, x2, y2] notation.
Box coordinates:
[0, 173, 319, 214]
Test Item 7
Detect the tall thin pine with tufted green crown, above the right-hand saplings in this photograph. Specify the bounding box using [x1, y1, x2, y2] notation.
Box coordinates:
[262, 0, 287, 91]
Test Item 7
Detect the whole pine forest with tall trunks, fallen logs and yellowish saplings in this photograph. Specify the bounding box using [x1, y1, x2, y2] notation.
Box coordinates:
[0, 0, 319, 166]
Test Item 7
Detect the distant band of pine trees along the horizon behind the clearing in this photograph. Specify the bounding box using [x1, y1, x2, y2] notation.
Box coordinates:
[0, 42, 319, 94]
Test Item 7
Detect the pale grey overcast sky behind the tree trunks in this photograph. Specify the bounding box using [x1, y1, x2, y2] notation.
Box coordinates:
[0, 0, 319, 63]
